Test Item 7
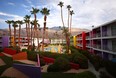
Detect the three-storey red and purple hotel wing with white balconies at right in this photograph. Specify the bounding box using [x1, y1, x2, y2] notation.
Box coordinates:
[76, 20, 116, 60]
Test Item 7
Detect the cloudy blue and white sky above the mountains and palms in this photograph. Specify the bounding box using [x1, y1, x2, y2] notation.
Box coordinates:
[0, 0, 116, 29]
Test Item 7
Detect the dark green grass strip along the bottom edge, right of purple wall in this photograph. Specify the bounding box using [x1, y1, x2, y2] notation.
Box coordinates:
[42, 71, 96, 78]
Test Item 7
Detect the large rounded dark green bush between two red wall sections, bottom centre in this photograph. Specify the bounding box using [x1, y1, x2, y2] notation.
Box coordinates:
[47, 57, 70, 72]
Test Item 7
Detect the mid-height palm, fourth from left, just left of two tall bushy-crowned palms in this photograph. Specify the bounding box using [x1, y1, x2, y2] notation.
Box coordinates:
[24, 15, 31, 47]
